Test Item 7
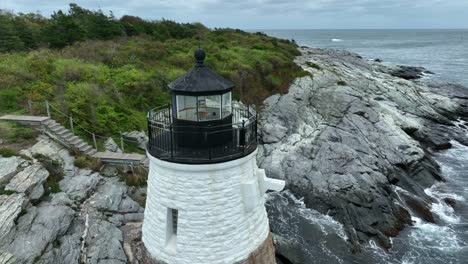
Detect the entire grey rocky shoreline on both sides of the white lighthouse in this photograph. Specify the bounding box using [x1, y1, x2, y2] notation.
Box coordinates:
[0, 47, 468, 264]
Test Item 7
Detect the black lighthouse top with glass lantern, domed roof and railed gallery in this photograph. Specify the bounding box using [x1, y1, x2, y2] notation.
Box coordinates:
[148, 48, 257, 163]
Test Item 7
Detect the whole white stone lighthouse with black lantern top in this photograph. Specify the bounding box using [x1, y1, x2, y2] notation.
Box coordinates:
[142, 48, 284, 264]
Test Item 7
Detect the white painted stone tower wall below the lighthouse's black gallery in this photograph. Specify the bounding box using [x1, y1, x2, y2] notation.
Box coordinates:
[143, 151, 284, 264]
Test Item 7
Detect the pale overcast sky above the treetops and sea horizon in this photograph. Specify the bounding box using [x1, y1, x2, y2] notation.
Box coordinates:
[0, 0, 468, 29]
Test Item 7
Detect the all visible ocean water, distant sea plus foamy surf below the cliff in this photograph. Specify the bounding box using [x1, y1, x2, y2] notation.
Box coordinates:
[264, 30, 468, 264]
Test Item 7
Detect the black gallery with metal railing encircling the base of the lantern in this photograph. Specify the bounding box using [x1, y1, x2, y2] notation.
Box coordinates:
[148, 104, 257, 164]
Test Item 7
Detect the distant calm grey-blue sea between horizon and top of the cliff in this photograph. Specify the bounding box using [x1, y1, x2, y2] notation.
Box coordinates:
[261, 29, 468, 87]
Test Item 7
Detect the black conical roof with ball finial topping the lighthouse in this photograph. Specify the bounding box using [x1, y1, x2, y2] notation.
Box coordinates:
[168, 48, 234, 95]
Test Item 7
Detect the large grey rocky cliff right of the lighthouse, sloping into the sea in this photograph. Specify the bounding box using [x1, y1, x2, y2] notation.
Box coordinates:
[258, 47, 468, 258]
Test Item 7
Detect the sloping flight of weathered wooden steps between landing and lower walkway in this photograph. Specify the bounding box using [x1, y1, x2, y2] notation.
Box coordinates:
[42, 118, 97, 156]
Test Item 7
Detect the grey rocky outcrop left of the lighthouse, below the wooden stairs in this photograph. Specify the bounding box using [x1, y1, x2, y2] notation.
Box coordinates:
[0, 136, 143, 264]
